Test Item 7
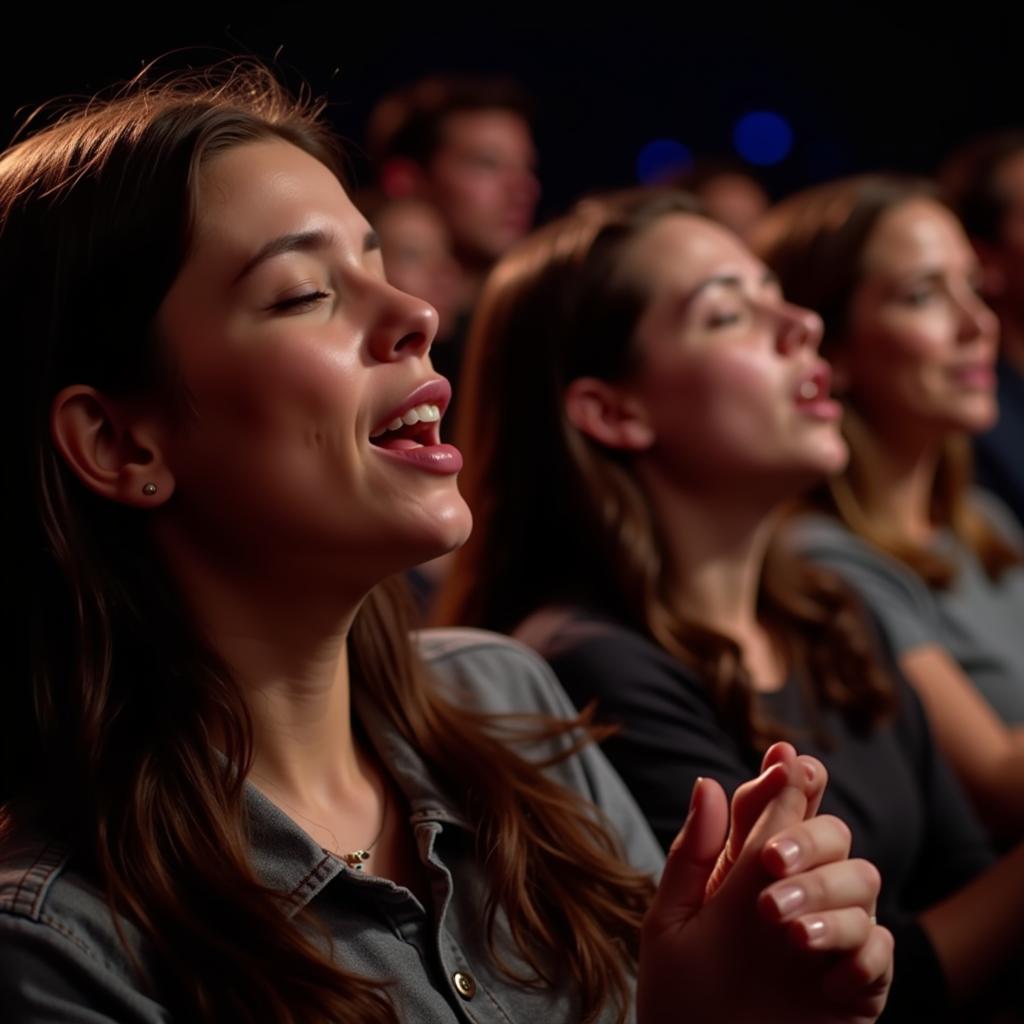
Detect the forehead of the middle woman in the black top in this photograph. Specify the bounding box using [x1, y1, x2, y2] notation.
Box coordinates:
[627, 213, 764, 289]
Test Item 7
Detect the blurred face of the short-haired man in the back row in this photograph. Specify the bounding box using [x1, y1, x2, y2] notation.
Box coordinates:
[428, 110, 540, 263]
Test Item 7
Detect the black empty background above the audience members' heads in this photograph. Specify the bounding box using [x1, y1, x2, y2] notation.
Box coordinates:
[0, 9, 1024, 215]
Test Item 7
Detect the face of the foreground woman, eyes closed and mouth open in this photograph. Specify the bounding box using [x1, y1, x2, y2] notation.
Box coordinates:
[151, 140, 469, 586]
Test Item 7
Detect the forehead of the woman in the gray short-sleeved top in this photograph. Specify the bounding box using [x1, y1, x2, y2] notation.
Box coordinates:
[864, 199, 974, 273]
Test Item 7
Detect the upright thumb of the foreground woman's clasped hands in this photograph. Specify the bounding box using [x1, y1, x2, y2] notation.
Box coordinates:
[649, 778, 729, 929]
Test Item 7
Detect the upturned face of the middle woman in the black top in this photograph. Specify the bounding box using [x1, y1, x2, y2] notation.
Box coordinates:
[585, 214, 847, 498]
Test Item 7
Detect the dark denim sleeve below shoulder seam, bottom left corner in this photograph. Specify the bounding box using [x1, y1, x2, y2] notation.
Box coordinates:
[0, 914, 171, 1024]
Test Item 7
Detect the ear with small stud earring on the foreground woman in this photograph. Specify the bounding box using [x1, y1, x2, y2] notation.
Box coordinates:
[50, 384, 174, 508]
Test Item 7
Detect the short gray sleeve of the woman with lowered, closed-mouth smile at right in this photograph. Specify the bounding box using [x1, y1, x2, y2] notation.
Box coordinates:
[788, 517, 944, 657]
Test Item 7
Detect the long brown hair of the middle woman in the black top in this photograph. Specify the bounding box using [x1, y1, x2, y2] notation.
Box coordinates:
[438, 191, 889, 749]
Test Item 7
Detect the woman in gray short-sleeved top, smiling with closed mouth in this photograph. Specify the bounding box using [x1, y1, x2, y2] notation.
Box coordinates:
[757, 175, 1024, 838]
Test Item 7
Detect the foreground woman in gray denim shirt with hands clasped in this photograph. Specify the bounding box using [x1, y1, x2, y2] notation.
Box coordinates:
[0, 69, 891, 1024]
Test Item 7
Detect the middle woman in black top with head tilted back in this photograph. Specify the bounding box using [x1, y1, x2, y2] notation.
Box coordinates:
[441, 194, 1024, 1020]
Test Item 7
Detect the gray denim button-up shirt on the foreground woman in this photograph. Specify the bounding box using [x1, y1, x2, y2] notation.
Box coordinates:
[0, 630, 662, 1024]
